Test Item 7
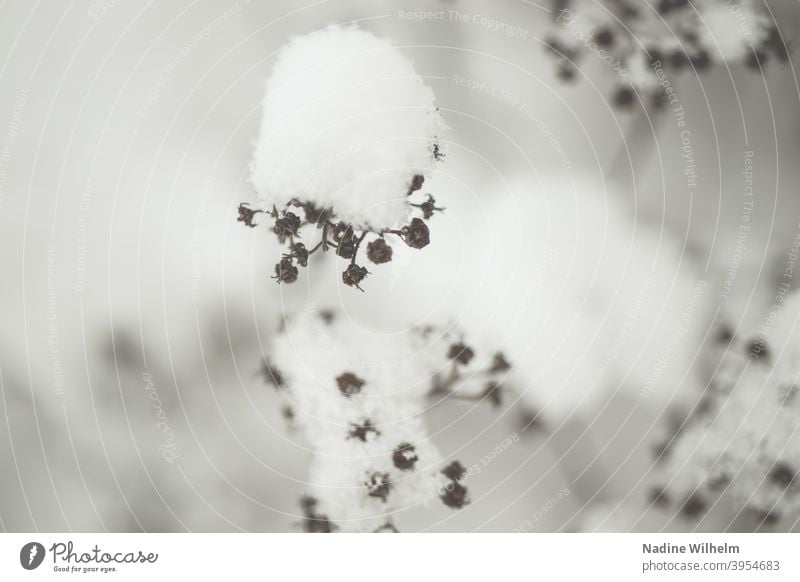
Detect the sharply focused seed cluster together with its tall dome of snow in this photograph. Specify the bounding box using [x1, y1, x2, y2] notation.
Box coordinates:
[239, 26, 445, 289]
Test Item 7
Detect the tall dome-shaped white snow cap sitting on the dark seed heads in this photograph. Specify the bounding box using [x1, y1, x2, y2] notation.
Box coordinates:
[251, 27, 445, 230]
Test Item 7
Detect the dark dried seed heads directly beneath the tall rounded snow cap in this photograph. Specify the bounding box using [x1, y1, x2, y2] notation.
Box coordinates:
[237, 171, 444, 291]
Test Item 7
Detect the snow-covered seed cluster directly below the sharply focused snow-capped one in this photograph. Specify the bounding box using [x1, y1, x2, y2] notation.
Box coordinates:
[264, 309, 509, 532]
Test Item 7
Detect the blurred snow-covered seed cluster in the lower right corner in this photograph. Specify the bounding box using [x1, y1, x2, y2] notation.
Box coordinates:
[652, 294, 800, 526]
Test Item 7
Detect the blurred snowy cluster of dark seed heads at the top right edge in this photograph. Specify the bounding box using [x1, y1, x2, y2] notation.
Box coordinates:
[545, 0, 789, 108]
